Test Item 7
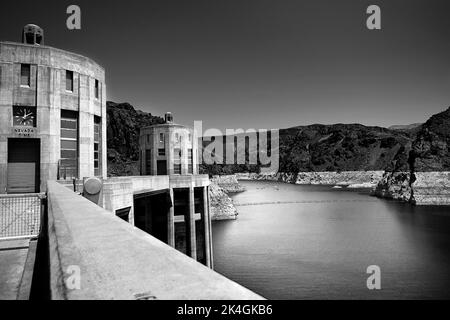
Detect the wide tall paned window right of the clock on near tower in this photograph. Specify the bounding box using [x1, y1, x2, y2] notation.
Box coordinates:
[59, 110, 78, 179]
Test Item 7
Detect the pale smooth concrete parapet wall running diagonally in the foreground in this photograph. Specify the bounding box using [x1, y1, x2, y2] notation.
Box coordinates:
[48, 181, 262, 300]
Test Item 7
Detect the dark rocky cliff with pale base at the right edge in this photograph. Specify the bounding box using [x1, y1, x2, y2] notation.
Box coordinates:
[375, 108, 450, 205]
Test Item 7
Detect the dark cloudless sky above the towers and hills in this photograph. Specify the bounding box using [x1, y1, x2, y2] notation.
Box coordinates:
[0, 0, 450, 129]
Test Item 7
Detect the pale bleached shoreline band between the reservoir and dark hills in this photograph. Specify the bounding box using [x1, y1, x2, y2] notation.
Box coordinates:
[210, 171, 450, 220]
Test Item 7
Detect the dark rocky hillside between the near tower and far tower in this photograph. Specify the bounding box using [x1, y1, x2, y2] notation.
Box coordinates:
[106, 101, 164, 176]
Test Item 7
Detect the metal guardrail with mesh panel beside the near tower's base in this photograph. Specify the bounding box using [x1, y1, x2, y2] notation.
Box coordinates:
[0, 193, 46, 240]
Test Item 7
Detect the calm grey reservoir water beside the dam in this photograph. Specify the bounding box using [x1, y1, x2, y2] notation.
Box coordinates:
[213, 181, 450, 299]
